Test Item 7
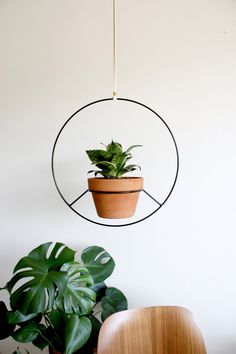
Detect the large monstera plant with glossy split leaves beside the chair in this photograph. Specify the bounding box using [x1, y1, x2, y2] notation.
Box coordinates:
[0, 242, 127, 354]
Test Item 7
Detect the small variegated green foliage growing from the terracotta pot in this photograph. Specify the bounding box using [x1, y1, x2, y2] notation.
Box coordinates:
[86, 140, 142, 178]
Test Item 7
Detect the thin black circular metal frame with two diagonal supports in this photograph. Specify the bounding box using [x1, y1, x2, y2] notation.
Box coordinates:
[51, 97, 179, 227]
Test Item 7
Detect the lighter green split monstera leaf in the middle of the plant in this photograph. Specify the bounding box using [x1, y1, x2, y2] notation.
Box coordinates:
[56, 262, 96, 316]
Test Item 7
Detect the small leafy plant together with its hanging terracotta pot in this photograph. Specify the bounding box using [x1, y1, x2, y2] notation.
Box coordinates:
[86, 140, 143, 219]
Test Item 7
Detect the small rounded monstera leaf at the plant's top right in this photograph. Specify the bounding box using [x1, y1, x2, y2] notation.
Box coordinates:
[81, 246, 115, 283]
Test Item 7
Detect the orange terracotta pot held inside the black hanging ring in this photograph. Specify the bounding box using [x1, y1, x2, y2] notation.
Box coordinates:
[88, 177, 143, 219]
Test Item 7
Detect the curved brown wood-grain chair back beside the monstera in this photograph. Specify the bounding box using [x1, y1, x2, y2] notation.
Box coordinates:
[97, 306, 206, 354]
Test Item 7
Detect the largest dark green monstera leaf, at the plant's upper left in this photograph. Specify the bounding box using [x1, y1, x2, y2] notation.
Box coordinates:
[6, 242, 75, 315]
